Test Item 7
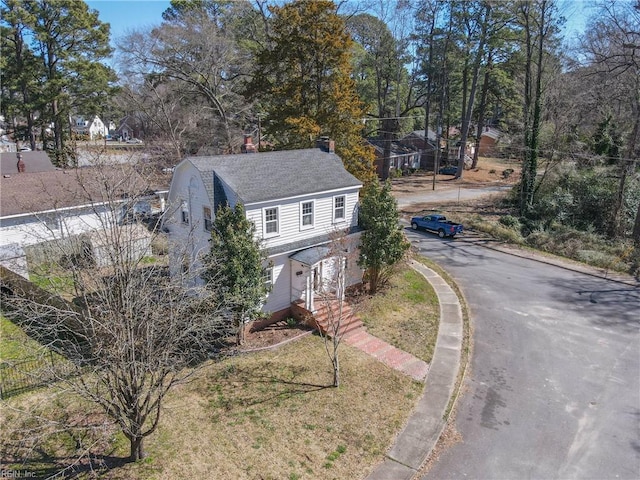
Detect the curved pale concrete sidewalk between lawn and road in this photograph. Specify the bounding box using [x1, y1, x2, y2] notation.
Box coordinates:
[367, 261, 463, 480]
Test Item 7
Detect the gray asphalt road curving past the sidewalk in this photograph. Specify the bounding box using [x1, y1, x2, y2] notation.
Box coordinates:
[407, 230, 640, 480]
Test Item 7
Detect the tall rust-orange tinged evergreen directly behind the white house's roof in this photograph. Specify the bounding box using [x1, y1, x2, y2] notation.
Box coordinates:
[247, 0, 375, 183]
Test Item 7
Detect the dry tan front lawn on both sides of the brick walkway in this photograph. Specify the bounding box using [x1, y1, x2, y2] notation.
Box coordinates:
[0, 267, 438, 480]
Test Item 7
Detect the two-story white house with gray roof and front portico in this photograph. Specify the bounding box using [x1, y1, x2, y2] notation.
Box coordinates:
[164, 142, 362, 319]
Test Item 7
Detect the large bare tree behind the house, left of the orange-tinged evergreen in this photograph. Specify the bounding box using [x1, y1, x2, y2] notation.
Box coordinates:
[120, 2, 256, 153]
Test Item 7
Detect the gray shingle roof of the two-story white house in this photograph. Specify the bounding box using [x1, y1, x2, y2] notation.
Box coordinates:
[186, 148, 362, 205]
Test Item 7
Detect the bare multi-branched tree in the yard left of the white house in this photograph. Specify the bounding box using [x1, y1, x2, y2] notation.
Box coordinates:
[2, 161, 226, 461]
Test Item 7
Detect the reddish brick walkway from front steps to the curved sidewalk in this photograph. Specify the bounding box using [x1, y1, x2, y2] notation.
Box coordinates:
[344, 328, 429, 382]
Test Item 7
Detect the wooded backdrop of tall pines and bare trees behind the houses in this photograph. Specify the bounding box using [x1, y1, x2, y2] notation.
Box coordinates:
[0, 0, 640, 270]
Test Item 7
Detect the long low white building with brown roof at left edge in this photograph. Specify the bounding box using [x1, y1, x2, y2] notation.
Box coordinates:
[0, 152, 163, 274]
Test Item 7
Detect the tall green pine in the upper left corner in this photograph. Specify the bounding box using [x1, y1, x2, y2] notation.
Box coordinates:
[2, 0, 116, 166]
